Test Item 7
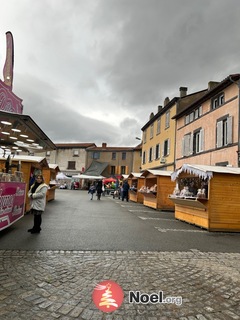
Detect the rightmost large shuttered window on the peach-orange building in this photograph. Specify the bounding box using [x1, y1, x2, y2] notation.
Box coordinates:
[217, 117, 233, 148]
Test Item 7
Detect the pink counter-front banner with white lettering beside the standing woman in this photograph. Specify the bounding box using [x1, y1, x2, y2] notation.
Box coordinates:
[0, 182, 26, 230]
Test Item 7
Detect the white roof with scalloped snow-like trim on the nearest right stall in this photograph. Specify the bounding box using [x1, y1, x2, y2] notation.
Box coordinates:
[171, 164, 240, 181]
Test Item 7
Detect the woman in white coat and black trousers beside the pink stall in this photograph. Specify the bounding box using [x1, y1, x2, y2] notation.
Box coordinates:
[28, 174, 48, 233]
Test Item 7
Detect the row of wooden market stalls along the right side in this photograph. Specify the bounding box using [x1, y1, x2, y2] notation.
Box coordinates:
[128, 164, 240, 232]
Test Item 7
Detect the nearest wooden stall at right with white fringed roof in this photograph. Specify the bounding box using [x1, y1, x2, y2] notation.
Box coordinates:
[169, 164, 240, 232]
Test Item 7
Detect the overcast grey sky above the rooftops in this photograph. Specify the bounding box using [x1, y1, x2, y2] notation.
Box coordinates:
[0, 0, 240, 146]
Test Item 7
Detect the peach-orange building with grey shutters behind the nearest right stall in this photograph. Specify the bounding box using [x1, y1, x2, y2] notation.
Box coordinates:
[175, 74, 240, 168]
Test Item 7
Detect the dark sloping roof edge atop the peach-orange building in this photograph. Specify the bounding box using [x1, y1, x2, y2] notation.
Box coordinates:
[172, 73, 240, 119]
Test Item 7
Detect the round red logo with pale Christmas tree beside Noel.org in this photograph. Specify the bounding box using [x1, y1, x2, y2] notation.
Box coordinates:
[92, 280, 124, 312]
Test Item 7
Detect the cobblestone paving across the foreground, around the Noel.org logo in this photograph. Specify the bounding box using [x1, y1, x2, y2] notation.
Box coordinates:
[0, 250, 240, 320]
